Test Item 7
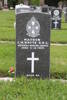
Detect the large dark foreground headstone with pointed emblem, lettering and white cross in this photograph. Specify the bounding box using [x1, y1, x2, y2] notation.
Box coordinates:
[16, 5, 50, 78]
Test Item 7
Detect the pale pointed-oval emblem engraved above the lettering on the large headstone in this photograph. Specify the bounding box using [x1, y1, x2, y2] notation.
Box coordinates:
[26, 17, 40, 37]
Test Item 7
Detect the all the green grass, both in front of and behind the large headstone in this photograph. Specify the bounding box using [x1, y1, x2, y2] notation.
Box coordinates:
[0, 11, 67, 100]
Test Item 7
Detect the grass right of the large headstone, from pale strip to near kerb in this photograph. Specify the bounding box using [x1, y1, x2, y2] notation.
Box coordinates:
[50, 46, 67, 79]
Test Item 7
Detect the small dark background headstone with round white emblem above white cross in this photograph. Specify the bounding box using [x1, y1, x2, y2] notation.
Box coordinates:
[51, 8, 62, 29]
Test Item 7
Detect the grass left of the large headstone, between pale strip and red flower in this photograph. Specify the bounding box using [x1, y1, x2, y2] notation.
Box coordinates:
[0, 44, 15, 76]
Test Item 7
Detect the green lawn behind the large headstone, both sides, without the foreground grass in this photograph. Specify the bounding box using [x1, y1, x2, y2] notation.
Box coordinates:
[0, 11, 67, 79]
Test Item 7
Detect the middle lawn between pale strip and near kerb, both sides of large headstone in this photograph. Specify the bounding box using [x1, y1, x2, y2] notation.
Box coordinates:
[0, 44, 67, 79]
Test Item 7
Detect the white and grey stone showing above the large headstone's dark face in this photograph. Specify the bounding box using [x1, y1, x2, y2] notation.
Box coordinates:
[15, 4, 50, 15]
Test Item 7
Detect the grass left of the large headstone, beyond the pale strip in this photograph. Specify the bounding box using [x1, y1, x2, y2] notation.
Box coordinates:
[0, 11, 16, 40]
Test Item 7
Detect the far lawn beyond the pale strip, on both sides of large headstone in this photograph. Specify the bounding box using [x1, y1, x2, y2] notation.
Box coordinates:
[0, 11, 67, 43]
